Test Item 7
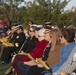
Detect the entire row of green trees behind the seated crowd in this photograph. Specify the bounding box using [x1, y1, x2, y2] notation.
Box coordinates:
[0, 0, 74, 27]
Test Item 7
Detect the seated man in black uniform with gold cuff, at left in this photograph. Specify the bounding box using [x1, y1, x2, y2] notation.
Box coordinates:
[1, 26, 25, 64]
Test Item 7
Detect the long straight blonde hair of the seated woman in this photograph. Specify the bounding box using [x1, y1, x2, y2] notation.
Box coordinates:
[50, 29, 60, 51]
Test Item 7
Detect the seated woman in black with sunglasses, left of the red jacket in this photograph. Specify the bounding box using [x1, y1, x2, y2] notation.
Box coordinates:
[2, 27, 39, 74]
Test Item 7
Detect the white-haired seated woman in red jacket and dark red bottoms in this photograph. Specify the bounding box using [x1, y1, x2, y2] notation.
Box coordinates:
[5, 29, 48, 74]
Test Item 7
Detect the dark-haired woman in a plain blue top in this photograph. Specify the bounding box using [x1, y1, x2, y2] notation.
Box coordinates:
[45, 29, 75, 75]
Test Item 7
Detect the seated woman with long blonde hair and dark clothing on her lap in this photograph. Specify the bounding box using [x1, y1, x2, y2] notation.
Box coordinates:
[18, 29, 62, 75]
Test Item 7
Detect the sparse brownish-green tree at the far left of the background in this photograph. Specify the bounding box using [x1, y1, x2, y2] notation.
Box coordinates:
[0, 0, 24, 25]
